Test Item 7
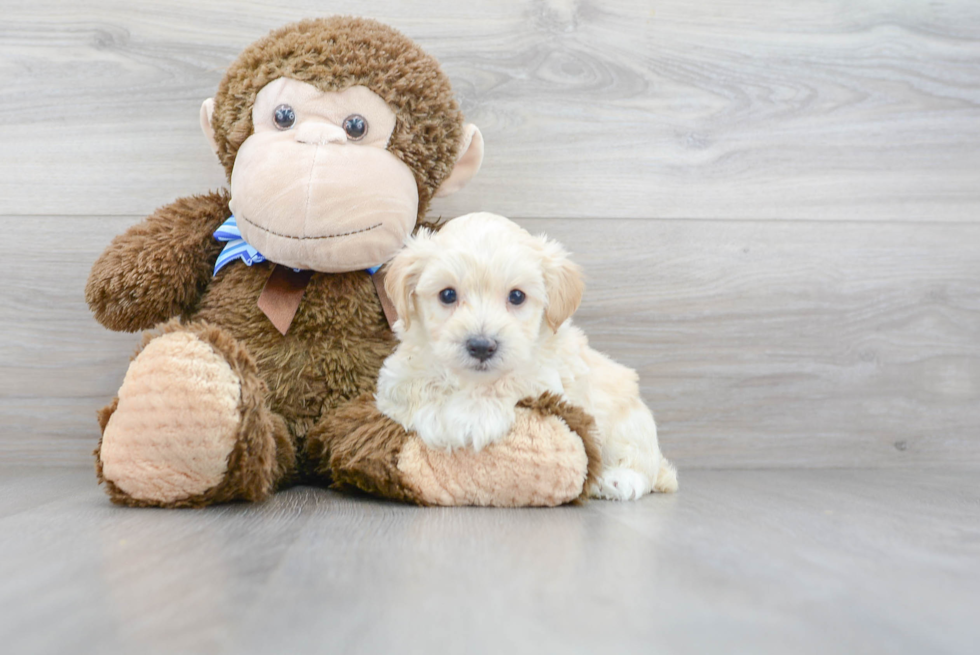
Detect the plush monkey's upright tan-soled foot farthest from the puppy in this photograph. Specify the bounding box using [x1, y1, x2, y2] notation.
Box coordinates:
[95, 322, 292, 507]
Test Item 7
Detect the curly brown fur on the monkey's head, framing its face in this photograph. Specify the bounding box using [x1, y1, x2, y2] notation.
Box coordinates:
[212, 16, 463, 220]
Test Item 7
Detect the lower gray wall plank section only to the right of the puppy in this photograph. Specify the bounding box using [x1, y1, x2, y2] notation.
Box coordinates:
[526, 220, 980, 467]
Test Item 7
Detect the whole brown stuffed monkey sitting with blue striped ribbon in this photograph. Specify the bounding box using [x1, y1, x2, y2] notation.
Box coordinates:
[86, 17, 598, 507]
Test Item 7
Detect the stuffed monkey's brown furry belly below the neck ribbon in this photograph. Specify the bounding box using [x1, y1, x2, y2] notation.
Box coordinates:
[195, 262, 395, 436]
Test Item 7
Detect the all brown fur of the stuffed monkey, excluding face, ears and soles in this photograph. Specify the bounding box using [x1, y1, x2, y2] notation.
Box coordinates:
[86, 18, 594, 507]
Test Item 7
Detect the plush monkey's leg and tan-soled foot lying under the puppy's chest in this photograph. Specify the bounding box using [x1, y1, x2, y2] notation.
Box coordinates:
[307, 394, 601, 507]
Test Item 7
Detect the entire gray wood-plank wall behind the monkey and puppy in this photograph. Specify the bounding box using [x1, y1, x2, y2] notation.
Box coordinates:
[0, 0, 980, 468]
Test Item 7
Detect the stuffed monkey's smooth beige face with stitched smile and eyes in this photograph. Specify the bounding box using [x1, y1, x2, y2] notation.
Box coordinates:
[225, 78, 419, 273]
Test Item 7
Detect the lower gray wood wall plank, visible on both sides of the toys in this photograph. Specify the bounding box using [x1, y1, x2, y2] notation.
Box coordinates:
[0, 217, 980, 468]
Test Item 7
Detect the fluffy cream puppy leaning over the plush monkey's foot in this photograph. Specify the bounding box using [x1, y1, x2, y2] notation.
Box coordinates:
[377, 213, 677, 500]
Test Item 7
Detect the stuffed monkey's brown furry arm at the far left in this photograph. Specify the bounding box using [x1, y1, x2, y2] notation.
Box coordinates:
[85, 190, 230, 332]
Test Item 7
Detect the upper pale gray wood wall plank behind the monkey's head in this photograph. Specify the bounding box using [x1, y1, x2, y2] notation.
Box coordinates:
[0, 0, 980, 222]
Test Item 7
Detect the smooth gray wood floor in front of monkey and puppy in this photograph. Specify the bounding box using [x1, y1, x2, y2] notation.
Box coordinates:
[0, 467, 980, 655]
